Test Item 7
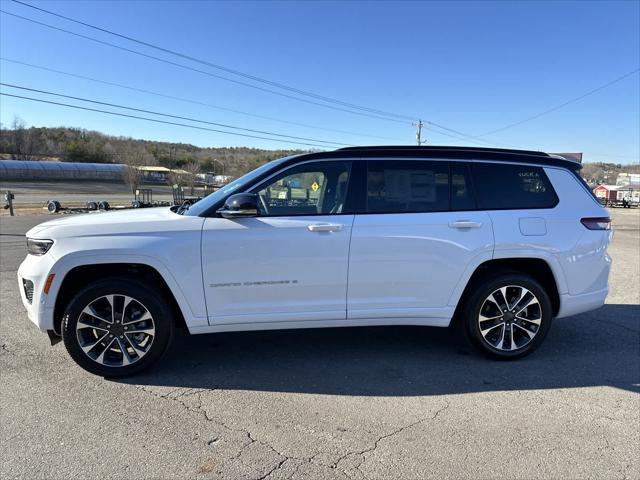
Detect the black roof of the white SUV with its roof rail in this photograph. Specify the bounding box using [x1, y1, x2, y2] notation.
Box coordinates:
[296, 145, 581, 170]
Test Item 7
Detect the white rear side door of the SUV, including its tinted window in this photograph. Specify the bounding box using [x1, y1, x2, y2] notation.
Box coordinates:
[347, 159, 493, 325]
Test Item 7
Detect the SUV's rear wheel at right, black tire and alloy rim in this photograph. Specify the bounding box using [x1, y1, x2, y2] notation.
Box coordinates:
[462, 273, 553, 359]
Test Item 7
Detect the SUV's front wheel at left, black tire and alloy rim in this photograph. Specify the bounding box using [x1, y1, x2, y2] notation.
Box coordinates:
[62, 277, 173, 377]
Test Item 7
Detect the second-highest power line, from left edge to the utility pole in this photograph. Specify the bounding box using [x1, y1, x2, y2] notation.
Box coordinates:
[0, 9, 408, 125]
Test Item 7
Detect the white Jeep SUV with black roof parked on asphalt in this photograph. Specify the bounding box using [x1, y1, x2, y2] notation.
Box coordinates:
[18, 147, 612, 376]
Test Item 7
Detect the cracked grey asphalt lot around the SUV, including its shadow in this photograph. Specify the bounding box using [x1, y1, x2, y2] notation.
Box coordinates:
[0, 209, 640, 479]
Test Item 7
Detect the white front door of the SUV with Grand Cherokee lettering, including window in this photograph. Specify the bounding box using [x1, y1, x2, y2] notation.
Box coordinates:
[201, 161, 354, 325]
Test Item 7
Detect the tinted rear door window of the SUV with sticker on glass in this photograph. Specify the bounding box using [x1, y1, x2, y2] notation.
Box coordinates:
[367, 160, 449, 213]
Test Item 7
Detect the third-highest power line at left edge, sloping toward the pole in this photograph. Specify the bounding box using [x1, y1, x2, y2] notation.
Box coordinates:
[0, 57, 400, 140]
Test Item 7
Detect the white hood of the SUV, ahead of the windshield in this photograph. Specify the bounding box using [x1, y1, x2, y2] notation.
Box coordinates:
[26, 207, 191, 238]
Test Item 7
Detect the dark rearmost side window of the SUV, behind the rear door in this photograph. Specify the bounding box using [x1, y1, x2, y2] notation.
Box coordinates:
[471, 162, 558, 210]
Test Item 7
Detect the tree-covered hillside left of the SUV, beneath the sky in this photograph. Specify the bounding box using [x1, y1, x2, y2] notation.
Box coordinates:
[0, 119, 303, 177]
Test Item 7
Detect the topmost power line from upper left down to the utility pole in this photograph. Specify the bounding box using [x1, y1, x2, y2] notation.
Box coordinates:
[13, 0, 414, 121]
